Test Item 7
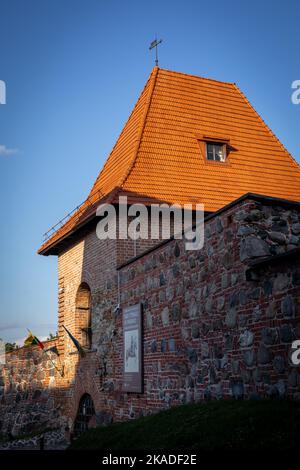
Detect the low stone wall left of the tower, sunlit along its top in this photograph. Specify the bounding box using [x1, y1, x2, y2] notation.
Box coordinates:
[0, 340, 63, 437]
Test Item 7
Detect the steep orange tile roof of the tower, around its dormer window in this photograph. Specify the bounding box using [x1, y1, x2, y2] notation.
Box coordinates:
[39, 67, 300, 254]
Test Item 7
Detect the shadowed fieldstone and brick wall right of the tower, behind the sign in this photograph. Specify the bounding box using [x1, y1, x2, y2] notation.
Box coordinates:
[110, 195, 300, 419]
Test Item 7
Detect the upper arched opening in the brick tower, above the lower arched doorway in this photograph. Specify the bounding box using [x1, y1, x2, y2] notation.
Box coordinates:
[76, 282, 92, 349]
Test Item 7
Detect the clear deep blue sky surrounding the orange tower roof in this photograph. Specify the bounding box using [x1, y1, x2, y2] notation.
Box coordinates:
[0, 0, 300, 340]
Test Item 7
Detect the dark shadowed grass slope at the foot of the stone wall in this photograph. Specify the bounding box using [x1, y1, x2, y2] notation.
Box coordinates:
[70, 400, 300, 450]
